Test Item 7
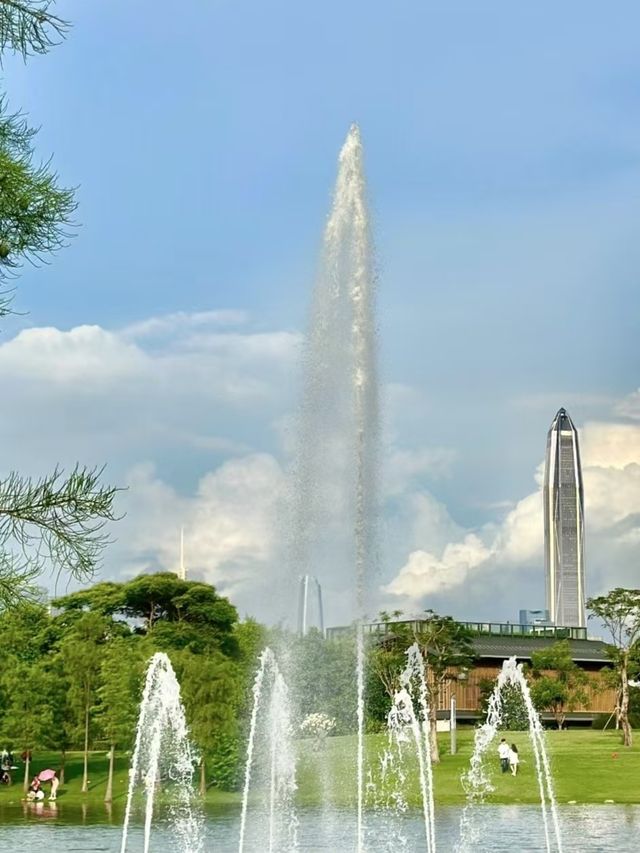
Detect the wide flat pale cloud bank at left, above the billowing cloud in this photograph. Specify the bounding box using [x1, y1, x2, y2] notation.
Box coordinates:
[0, 312, 300, 477]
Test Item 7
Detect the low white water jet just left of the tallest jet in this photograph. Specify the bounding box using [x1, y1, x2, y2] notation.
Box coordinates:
[238, 648, 298, 853]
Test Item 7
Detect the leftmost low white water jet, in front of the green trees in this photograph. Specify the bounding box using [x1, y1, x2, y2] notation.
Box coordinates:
[120, 652, 203, 853]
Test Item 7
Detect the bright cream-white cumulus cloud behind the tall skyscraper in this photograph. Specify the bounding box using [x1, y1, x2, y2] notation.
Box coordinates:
[383, 422, 640, 618]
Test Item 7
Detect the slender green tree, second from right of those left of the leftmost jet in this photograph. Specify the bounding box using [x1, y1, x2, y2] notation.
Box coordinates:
[61, 613, 109, 794]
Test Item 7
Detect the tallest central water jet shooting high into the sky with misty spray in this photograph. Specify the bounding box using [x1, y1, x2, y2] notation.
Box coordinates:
[292, 125, 379, 851]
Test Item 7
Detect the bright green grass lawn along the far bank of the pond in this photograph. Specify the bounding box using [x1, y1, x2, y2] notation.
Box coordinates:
[0, 729, 640, 811]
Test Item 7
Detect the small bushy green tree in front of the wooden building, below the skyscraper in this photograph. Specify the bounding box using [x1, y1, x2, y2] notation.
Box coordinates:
[531, 640, 589, 729]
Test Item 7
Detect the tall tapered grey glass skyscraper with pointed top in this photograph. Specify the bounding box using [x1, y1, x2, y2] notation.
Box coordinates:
[543, 409, 586, 628]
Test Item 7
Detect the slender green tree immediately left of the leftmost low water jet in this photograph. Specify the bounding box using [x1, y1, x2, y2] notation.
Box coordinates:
[97, 637, 144, 803]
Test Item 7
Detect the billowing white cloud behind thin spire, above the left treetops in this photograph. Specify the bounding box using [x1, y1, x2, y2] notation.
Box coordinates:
[122, 453, 285, 604]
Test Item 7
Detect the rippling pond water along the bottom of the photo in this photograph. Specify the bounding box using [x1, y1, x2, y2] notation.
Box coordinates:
[0, 805, 640, 853]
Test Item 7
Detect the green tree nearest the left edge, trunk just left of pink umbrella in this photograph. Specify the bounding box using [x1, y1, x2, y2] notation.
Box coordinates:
[2, 663, 52, 791]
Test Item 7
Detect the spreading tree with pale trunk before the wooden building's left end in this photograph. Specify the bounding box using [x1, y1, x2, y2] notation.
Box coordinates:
[371, 610, 475, 763]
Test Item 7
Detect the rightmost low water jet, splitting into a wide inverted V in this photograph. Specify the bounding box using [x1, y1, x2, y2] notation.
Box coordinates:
[458, 657, 562, 853]
